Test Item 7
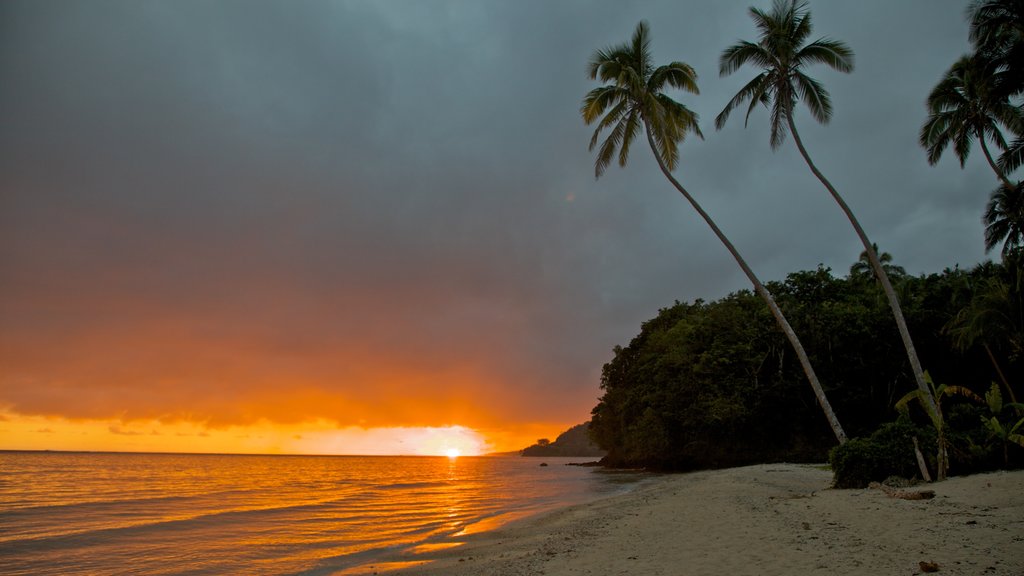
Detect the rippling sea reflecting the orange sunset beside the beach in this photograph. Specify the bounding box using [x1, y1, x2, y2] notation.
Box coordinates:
[0, 452, 638, 576]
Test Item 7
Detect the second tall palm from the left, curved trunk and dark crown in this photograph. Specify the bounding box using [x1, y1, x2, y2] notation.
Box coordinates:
[715, 0, 935, 422]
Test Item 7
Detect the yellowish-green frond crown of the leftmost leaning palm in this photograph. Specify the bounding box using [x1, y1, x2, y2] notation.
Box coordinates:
[580, 22, 703, 177]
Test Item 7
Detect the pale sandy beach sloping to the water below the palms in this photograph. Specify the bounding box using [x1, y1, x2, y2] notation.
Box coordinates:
[362, 464, 1024, 576]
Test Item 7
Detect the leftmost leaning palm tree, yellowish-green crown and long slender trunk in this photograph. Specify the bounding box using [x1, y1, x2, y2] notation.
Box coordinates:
[580, 17, 846, 444]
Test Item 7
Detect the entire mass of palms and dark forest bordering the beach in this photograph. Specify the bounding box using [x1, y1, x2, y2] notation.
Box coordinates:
[581, 0, 1024, 487]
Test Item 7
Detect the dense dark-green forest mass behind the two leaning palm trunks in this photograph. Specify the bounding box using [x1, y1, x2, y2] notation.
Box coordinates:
[590, 258, 1024, 474]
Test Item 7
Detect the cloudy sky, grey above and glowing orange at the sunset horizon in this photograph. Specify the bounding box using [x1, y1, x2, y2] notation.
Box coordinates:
[0, 0, 996, 454]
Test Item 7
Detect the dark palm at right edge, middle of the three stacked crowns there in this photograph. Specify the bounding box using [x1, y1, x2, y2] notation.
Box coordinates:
[921, 53, 1021, 190]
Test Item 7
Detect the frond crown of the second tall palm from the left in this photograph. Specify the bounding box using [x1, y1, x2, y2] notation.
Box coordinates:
[715, 0, 853, 150]
